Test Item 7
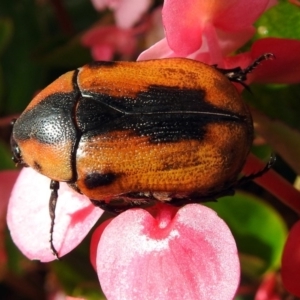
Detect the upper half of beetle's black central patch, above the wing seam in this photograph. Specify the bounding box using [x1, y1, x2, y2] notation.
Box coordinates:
[81, 85, 244, 121]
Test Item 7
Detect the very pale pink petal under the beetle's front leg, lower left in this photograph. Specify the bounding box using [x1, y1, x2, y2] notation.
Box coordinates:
[7, 168, 103, 262]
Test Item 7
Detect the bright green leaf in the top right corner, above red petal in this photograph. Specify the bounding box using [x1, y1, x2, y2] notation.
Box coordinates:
[256, 0, 300, 39]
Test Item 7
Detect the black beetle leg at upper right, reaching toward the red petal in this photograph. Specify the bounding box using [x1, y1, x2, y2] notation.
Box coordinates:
[216, 53, 275, 84]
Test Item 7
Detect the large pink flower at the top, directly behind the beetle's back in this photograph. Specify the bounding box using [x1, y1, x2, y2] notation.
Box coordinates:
[139, 0, 276, 66]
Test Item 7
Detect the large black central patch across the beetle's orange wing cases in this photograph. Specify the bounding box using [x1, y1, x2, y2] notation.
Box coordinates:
[76, 86, 248, 143]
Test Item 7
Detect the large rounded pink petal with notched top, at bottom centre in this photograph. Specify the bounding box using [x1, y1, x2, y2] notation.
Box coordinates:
[97, 204, 240, 300]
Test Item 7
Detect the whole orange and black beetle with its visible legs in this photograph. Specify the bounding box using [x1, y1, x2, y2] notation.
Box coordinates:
[11, 53, 273, 256]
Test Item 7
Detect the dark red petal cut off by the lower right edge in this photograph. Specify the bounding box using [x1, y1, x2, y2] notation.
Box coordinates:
[281, 221, 300, 297]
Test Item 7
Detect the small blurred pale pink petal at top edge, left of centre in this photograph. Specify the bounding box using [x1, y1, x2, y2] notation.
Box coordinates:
[92, 0, 152, 29]
